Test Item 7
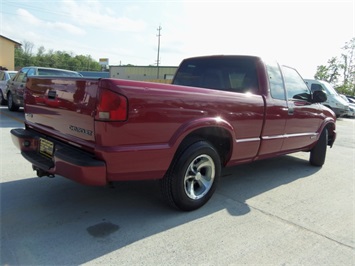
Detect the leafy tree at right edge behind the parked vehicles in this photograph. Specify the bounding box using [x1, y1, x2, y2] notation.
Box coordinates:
[314, 38, 355, 96]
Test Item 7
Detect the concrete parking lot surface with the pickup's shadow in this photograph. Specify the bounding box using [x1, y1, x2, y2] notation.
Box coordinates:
[0, 107, 355, 265]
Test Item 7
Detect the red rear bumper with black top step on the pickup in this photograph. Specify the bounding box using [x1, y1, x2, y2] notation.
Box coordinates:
[11, 128, 107, 186]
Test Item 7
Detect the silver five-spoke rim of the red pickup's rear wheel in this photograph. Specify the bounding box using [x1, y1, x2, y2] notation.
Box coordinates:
[184, 154, 215, 200]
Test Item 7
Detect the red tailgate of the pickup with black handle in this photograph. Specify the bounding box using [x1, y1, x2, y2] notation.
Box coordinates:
[25, 77, 99, 149]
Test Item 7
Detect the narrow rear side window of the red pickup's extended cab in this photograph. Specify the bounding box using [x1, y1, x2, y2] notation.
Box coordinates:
[266, 62, 286, 100]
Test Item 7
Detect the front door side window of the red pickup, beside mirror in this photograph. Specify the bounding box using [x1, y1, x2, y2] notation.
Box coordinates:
[282, 66, 310, 101]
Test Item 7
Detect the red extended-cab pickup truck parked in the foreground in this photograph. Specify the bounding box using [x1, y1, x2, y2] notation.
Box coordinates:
[11, 56, 336, 210]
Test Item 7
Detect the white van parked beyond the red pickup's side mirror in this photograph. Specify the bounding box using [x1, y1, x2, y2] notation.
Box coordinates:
[304, 79, 349, 117]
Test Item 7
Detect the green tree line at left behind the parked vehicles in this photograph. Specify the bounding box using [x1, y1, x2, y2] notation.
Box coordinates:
[15, 41, 101, 71]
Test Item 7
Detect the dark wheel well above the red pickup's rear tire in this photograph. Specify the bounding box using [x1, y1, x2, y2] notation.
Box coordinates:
[177, 127, 233, 165]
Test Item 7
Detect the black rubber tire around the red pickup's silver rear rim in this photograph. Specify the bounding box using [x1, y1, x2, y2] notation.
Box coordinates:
[160, 140, 221, 211]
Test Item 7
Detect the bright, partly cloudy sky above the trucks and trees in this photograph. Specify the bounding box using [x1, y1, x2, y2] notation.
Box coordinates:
[0, 0, 355, 78]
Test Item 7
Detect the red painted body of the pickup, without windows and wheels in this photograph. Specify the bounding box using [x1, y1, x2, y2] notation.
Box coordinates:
[13, 56, 335, 185]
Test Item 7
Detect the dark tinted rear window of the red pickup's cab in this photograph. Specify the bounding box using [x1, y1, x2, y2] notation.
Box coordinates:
[173, 57, 259, 93]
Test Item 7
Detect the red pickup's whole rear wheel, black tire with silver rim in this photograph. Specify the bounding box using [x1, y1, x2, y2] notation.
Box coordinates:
[161, 141, 221, 211]
